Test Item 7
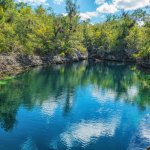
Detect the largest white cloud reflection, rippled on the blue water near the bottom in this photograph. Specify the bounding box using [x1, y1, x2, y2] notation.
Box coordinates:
[60, 118, 119, 149]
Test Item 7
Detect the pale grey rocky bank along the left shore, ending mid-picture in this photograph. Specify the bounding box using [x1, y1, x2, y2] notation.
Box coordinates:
[0, 52, 88, 78]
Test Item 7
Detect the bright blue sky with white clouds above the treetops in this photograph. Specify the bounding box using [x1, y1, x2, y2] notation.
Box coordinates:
[16, 0, 150, 23]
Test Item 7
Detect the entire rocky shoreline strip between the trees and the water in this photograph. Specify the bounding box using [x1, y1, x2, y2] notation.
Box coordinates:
[0, 52, 150, 79]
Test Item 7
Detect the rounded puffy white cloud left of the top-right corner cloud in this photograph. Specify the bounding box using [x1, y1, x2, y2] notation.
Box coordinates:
[97, 3, 117, 14]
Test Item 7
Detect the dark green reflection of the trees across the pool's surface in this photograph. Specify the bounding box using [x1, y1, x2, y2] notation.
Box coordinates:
[0, 61, 150, 131]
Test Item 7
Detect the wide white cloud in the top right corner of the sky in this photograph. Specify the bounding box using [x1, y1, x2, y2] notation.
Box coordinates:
[113, 0, 150, 10]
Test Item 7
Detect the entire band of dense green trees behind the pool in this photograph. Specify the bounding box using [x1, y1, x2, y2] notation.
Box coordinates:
[0, 0, 150, 61]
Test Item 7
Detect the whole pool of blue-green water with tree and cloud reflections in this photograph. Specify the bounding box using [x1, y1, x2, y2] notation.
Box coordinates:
[0, 62, 150, 150]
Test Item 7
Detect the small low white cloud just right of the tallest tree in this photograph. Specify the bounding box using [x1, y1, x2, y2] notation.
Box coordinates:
[80, 11, 98, 20]
